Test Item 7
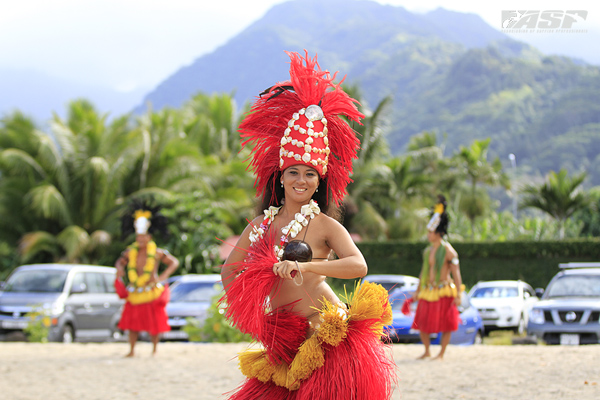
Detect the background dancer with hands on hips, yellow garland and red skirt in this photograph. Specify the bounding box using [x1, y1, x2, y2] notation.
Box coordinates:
[115, 202, 179, 357]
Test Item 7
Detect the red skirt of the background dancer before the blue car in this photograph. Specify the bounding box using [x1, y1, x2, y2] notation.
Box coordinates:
[412, 297, 460, 333]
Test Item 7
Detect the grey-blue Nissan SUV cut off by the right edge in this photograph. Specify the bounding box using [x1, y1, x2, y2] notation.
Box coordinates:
[527, 262, 600, 345]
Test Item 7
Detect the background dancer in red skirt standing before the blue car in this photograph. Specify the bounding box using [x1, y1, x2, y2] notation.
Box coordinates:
[412, 195, 462, 360]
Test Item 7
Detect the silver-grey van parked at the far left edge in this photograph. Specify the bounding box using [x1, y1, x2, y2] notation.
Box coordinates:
[0, 264, 124, 342]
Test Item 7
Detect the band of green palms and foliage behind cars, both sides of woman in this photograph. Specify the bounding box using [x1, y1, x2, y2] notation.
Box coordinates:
[0, 87, 600, 274]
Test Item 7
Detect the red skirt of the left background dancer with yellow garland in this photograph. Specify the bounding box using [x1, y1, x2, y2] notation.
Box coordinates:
[119, 286, 171, 335]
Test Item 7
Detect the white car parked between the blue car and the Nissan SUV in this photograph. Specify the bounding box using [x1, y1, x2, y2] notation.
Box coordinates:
[469, 281, 538, 334]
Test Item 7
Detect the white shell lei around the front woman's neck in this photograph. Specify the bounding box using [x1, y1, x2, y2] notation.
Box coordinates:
[249, 199, 321, 260]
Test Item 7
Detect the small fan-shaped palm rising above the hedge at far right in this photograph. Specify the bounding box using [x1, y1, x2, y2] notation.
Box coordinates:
[519, 168, 589, 239]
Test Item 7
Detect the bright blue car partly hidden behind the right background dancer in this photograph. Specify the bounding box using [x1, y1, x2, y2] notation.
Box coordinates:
[384, 289, 484, 345]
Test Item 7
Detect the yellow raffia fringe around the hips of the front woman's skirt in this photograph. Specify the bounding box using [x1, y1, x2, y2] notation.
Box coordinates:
[239, 282, 392, 390]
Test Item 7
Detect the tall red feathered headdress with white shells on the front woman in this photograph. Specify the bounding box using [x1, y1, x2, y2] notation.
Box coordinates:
[239, 52, 364, 205]
